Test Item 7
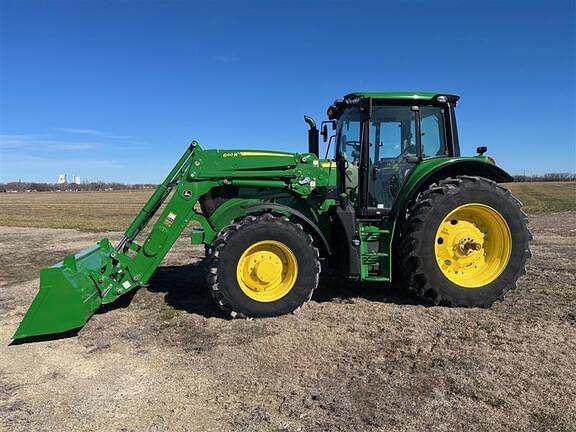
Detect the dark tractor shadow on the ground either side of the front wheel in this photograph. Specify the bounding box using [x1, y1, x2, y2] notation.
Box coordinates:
[147, 261, 427, 318]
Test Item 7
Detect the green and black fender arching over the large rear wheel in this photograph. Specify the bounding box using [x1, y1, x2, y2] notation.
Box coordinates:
[390, 156, 514, 216]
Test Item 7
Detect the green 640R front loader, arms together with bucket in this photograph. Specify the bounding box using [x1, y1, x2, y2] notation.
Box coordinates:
[13, 141, 328, 339]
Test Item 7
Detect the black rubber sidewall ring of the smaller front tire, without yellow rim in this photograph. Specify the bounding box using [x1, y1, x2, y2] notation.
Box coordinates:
[217, 222, 317, 317]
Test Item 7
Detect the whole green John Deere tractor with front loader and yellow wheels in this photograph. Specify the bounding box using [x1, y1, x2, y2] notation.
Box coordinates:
[13, 92, 531, 339]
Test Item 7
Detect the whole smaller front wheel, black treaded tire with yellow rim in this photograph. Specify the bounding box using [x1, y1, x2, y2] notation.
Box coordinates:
[208, 214, 320, 318]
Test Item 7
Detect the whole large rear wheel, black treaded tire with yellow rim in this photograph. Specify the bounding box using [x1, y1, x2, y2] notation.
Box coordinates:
[399, 176, 532, 307]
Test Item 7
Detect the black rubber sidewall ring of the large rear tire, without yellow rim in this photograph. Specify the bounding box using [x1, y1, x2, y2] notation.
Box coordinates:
[418, 184, 528, 306]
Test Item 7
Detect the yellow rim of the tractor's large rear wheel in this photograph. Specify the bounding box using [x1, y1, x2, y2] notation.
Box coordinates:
[434, 203, 512, 288]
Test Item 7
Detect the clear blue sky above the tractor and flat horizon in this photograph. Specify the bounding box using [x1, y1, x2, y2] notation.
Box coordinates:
[0, 0, 576, 183]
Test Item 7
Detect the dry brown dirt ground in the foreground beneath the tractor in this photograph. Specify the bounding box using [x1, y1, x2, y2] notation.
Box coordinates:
[0, 212, 576, 431]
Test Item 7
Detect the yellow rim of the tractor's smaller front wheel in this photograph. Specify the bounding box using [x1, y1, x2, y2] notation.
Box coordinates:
[236, 240, 298, 302]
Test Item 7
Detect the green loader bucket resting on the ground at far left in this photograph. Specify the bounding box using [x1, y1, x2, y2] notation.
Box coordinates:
[12, 241, 110, 340]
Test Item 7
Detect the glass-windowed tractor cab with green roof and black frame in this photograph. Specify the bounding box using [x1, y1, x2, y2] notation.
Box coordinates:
[328, 93, 460, 216]
